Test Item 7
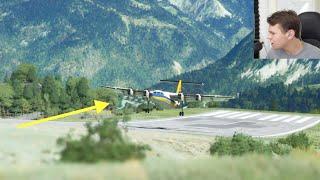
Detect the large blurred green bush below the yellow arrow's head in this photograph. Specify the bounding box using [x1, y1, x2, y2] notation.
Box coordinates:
[57, 119, 150, 163]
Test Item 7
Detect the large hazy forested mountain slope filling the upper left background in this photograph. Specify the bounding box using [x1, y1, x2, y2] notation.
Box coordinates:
[0, 0, 250, 88]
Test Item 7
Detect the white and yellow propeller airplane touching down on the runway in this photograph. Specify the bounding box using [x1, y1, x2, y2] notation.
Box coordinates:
[102, 80, 235, 116]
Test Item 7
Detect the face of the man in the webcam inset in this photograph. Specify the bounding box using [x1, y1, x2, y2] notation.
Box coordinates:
[268, 24, 289, 49]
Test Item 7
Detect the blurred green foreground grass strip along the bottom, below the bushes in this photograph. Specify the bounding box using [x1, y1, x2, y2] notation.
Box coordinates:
[0, 152, 320, 180]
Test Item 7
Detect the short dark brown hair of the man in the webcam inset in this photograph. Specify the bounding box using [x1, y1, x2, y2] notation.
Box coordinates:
[267, 10, 301, 39]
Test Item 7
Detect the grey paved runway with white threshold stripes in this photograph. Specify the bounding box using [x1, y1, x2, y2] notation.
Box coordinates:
[127, 110, 320, 137]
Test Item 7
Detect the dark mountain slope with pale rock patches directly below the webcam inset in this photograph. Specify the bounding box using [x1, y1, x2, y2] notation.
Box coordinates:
[154, 33, 320, 95]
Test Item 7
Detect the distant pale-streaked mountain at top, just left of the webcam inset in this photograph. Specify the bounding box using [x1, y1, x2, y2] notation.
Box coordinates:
[168, 0, 254, 43]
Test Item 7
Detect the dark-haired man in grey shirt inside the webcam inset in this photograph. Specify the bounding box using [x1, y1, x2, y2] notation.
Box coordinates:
[267, 10, 320, 59]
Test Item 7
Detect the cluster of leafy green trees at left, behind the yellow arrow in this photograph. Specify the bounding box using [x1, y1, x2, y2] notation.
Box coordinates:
[0, 64, 118, 116]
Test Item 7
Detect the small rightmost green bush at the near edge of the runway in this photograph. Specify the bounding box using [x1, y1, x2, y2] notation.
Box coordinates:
[278, 132, 311, 150]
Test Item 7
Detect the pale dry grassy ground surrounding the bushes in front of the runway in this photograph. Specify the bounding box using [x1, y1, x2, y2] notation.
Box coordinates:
[0, 109, 320, 179]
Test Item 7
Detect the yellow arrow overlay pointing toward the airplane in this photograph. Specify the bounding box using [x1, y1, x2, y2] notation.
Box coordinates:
[17, 100, 109, 128]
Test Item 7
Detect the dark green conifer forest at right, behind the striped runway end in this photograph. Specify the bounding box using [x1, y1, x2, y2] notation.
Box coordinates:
[223, 83, 320, 113]
